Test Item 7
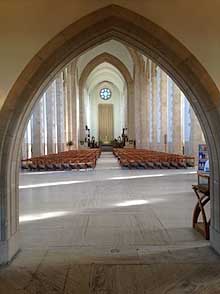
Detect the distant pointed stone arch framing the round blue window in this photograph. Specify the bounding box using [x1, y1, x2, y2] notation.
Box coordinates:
[79, 52, 134, 139]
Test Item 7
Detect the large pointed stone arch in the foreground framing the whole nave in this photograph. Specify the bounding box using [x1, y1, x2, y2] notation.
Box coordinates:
[0, 5, 220, 263]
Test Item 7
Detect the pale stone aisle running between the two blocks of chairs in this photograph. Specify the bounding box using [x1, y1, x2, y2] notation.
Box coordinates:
[96, 152, 121, 170]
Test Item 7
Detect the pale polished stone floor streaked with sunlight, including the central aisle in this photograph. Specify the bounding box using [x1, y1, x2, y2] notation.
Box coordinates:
[0, 153, 220, 294]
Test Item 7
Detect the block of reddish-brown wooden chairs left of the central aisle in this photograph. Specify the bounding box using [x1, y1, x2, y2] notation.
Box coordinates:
[21, 149, 101, 171]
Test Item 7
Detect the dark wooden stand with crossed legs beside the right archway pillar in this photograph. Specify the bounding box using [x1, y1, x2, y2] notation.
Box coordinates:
[192, 172, 210, 240]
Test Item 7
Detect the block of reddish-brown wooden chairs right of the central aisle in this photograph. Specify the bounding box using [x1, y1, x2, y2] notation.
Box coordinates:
[113, 148, 195, 169]
